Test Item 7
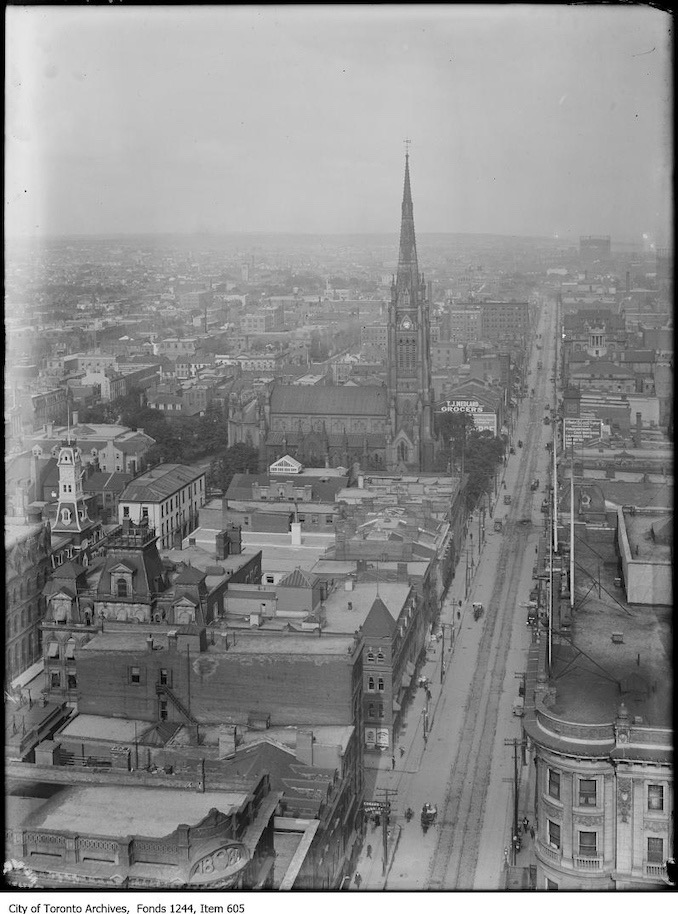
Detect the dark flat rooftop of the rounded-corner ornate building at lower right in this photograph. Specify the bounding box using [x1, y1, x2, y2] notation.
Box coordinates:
[551, 539, 673, 727]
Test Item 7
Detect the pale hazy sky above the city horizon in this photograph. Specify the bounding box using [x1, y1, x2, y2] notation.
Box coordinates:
[5, 5, 672, 243]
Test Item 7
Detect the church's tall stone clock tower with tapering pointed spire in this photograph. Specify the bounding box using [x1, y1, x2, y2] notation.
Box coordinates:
[387, 153, 436, 472]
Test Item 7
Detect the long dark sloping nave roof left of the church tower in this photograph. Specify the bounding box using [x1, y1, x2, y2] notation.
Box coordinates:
[271, 384, 388, 419]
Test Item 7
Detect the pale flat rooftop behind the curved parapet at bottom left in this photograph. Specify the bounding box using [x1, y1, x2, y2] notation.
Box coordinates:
[15, 784, 248, 838]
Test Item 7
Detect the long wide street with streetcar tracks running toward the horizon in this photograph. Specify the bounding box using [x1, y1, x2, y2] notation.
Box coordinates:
[352, 306, 556, 890]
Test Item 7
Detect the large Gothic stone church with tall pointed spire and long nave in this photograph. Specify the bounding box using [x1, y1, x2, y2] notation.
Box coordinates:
[244, 152, 436, 473]
